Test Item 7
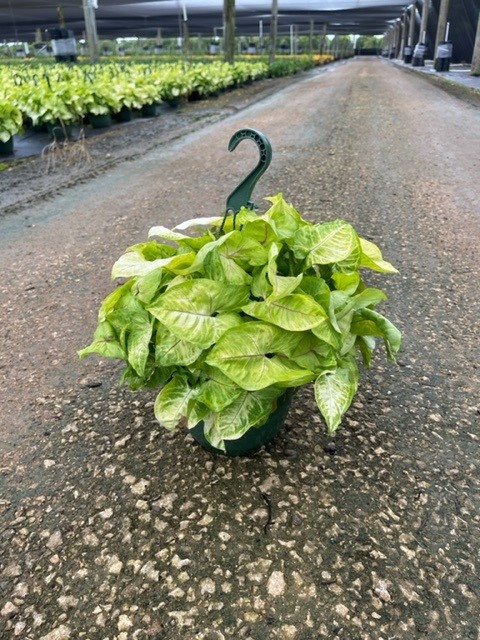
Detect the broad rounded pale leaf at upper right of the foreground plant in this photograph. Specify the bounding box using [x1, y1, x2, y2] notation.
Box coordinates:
[292, 220, 360, 270]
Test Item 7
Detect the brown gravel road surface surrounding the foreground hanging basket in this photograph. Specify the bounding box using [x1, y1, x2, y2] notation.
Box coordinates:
[0, 60, 480, 640]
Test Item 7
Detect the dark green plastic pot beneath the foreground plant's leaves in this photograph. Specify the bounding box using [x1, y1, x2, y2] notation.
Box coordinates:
[190, 390, 293, 456]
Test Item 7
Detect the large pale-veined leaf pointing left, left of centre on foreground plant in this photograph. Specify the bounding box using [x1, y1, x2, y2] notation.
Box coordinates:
[148, 278, 248, 349]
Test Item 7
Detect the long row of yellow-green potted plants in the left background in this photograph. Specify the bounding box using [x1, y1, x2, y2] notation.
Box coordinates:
[0, 56, 336, 153]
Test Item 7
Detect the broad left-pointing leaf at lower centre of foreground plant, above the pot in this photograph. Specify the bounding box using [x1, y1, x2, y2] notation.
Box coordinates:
[206, 322, 312, 391]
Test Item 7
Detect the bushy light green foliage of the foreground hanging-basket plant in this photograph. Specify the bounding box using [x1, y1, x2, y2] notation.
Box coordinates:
[79, 194, 400, 448]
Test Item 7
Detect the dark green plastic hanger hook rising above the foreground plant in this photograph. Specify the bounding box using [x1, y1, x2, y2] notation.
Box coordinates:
[227, 129, 272, 215]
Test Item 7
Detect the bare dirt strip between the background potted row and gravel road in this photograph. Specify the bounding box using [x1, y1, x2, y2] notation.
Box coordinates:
[0, 70, 319, 216]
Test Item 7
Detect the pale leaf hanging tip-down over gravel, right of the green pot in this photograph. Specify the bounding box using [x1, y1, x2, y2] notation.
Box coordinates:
[314, 359, 358, 434]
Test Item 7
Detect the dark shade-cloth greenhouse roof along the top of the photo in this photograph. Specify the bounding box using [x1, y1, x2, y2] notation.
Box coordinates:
[0, 0, 405, 41]
